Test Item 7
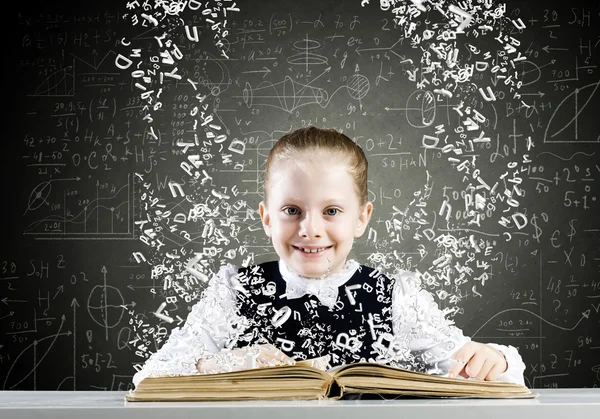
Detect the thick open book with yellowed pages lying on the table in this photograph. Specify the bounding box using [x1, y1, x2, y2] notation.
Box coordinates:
[125, 346, 536, 401]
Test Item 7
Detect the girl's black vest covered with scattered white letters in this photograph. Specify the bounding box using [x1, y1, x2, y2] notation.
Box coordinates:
[237, 261, 394, 366]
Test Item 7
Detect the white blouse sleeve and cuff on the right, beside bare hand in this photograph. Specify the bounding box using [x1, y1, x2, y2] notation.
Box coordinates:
[392, 271, 525, 384]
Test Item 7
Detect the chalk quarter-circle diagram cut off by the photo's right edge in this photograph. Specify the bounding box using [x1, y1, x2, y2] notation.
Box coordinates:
[544, 80, 600, 143]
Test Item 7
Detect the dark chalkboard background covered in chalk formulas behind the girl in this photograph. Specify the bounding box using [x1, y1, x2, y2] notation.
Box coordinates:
[0, 0, 600, 390]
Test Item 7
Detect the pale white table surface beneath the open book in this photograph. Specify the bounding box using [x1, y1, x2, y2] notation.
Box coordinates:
[0, 389, 600, 419]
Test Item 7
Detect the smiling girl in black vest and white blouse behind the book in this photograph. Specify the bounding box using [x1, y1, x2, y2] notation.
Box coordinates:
[133, 127, 525, 386]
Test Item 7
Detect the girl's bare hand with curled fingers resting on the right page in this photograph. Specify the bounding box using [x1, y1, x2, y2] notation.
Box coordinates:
[448, 341, 508, 381]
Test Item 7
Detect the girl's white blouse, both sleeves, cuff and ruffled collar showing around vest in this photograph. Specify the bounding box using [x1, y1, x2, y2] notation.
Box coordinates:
[133, 259, 525, 387]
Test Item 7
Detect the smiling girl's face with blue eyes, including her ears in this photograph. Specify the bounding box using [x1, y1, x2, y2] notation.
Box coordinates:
[259, 155, 373, 278]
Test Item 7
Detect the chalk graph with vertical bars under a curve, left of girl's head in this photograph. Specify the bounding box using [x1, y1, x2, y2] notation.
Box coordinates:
[23, 174, 135, 239]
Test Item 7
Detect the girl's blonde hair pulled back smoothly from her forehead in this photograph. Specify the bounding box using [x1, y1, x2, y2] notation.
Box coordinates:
[263, 126, 369, 208]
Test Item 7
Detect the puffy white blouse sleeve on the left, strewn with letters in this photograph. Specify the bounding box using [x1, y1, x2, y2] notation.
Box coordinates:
[133, 263, 247, 387]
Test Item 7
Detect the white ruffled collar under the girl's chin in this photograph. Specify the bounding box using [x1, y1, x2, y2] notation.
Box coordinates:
[279, 259, 360, 307]
